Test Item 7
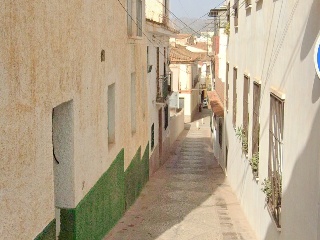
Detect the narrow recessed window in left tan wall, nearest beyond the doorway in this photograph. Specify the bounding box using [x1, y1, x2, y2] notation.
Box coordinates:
[108, 83, 116, 143]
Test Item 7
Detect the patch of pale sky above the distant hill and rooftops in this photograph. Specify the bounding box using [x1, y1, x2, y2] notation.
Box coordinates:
[170, 0, 224, 18]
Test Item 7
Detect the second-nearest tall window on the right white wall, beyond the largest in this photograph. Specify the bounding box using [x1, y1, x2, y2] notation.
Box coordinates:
[252, 82, 261, 156]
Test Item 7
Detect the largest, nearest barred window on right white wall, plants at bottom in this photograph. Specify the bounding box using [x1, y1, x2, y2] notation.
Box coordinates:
[268, 93, 284, 227]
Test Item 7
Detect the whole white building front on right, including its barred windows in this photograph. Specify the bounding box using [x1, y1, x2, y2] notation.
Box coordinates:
[223, 0, 320, 240]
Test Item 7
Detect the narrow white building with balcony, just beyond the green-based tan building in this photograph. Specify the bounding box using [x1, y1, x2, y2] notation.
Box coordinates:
[145, 0, 175, 175]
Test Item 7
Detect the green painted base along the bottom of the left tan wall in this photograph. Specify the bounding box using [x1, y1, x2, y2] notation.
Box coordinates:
[36, 144, 149, 240]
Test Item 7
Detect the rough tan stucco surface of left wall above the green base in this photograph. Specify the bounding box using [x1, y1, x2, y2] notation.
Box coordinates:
[0, 0, 148, 239]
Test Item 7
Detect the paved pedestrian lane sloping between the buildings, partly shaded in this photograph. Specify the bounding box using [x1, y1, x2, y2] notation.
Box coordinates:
[105, 110, 256, 240]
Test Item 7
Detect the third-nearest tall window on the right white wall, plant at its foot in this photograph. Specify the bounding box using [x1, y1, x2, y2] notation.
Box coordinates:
[242, 75, 250, 154]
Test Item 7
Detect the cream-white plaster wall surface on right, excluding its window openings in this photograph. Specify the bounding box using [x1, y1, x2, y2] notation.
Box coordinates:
[225, 0, 320, 240]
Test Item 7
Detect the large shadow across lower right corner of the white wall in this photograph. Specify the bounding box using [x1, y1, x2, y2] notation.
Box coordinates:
[264, 94, 320, 240]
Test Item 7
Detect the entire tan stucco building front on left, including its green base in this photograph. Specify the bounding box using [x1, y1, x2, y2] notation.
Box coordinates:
[0, 0, 150, 239]
